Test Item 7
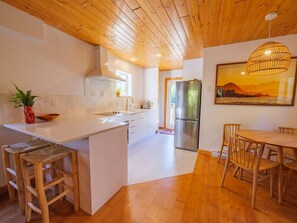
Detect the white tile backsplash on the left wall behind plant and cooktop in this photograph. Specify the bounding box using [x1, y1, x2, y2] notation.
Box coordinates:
[0, 79, 136, 124]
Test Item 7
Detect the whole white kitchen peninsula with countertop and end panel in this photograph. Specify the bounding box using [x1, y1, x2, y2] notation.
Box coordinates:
[4, 116, 128, 215]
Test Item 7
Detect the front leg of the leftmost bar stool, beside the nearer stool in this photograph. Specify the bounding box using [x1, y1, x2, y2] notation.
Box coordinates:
[13, 153, 25, 214]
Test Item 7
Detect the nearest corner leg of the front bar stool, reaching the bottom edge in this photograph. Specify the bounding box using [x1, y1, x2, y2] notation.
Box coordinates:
[34, 163, 49, 223]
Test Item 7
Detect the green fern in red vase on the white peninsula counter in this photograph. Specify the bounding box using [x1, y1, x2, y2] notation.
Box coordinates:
[10, 83, 37, 124]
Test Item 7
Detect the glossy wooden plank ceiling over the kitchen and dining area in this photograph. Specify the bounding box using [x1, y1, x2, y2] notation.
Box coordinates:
[3, 0, 297, 70]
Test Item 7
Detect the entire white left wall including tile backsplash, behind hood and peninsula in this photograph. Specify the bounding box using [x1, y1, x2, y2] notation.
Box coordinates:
[0, 2, 143, 187]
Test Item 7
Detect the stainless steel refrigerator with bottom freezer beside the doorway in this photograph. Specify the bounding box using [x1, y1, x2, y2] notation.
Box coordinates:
[174, 79, 202, 151]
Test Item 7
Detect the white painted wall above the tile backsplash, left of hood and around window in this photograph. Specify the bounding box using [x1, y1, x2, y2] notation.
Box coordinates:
[0, 2, 143, 100]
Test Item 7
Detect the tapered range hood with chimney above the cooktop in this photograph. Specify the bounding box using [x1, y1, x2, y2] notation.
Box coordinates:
[85, 46, 126, 81]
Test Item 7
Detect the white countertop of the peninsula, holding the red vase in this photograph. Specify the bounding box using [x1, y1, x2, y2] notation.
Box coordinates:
[3, 115, 127, 144]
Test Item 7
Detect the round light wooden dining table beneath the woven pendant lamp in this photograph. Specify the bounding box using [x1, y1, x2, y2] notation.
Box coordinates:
[235, 129, 297, 203]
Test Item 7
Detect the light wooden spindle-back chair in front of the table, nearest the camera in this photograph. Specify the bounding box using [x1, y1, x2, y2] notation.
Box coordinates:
[221, 136, 279, 208]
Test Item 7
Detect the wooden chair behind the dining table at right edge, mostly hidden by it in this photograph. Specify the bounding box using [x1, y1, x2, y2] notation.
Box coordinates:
[266, 127, 297, 160]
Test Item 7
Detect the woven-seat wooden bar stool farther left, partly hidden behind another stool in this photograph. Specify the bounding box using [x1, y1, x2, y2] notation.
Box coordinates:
[2, 139, 50, 214]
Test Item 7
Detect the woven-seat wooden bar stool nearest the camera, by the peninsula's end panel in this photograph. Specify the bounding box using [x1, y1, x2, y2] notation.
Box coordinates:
[21, 145, 79, 223]
